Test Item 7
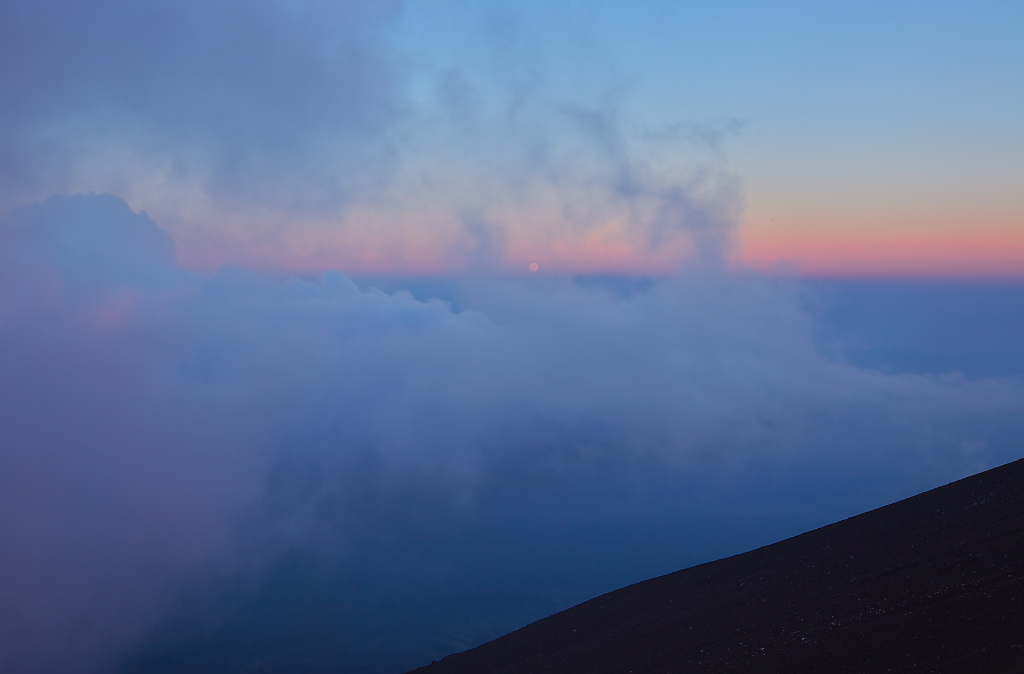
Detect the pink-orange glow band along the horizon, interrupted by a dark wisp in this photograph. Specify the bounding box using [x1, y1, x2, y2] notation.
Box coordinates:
[161, 206, 1024, 279]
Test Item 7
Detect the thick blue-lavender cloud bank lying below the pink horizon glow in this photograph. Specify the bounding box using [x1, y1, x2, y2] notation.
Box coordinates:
[0, 196, 1024, 672]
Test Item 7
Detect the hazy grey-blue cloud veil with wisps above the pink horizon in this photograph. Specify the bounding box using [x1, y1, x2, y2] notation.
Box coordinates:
[0, 0, 742, 272]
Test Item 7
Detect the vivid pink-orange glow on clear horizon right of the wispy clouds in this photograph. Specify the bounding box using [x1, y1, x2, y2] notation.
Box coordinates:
[733, 191, 1024, 280]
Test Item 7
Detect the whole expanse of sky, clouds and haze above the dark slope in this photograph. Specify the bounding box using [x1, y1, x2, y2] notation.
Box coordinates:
[0, 0, 1024, 674]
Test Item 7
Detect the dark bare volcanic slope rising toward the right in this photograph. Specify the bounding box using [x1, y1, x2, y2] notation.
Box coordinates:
[407, 459, 1024, 674]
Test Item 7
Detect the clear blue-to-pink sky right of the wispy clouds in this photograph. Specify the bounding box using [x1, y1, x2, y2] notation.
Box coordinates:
[393, 2, 1024, 276]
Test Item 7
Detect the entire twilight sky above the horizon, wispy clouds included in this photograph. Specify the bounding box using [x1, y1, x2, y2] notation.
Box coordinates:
[0, 0, 1024, 276]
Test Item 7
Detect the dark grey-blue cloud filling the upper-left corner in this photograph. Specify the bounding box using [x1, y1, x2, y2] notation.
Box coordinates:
[0, 0, 401, 209]
